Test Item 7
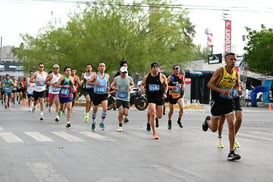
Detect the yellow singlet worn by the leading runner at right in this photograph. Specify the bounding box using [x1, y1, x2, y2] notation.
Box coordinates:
[212, 66, 238, 99]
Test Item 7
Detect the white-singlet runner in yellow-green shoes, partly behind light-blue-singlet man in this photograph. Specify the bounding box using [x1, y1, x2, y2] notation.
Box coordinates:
[81, 64, 94, 123]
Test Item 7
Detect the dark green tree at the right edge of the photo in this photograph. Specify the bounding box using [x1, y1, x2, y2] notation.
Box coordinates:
[243, 25, 273, 76]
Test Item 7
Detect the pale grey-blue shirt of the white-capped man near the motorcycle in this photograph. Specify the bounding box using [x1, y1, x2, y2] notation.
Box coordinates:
[116, 75, 130, 101]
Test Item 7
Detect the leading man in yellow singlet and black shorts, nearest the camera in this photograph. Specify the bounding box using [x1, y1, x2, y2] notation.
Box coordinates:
[202, 53, 241, 161]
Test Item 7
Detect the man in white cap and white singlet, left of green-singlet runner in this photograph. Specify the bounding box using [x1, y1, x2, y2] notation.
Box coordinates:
[45, 64, 62, 122]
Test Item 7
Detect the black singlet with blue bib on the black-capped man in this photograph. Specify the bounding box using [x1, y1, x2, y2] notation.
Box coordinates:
[146, 73, 164, 98]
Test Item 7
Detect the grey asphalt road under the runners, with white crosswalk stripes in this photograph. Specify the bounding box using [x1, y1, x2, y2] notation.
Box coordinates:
[0, 105, 273, 182]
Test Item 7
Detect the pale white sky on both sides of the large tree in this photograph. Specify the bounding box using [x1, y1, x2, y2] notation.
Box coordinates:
[0, 0, 273, 54]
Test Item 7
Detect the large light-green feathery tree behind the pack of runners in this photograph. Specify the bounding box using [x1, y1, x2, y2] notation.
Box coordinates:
[14, 0, 199, 73]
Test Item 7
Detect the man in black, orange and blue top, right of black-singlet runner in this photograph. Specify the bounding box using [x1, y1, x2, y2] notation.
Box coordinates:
[168, 65, 185, 130]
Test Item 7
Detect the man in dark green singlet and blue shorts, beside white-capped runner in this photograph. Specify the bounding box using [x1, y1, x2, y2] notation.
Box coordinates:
[56, 66, 75, 128]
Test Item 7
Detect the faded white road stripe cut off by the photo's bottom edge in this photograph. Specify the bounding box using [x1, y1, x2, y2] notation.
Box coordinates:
[26, 162, 69, 182]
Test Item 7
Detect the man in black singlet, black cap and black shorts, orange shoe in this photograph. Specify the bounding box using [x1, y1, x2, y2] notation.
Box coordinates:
[141, 63, 168, 139]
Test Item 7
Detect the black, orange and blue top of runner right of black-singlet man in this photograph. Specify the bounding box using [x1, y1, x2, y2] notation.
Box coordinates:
[169, 74, 184, 99]
